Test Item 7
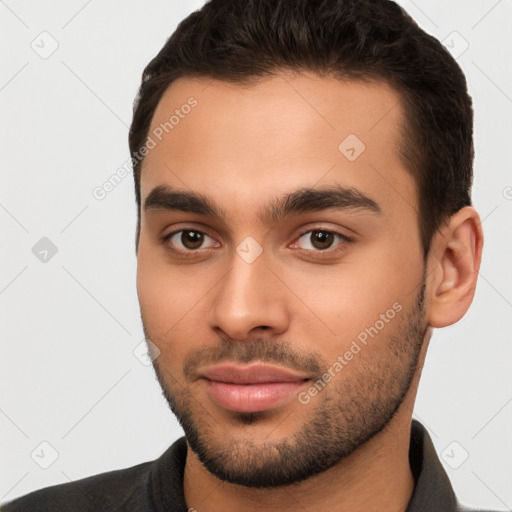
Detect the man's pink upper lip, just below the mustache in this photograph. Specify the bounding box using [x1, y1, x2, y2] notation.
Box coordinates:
[199, 363, 309, 384]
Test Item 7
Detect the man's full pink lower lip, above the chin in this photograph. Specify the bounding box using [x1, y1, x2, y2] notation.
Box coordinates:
[204, 379, 307, 412]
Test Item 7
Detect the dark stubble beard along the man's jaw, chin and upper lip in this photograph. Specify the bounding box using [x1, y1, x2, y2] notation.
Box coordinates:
[145, 281, 427, 488]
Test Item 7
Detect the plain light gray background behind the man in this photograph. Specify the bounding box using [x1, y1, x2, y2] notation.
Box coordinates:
[0, 0, 512, 509]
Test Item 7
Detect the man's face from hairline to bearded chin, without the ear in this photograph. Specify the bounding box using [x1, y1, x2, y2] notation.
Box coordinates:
[137, 75, 427, 487]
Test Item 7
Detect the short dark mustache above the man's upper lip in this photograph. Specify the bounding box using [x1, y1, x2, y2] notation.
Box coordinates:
[183, 338, 328, 380]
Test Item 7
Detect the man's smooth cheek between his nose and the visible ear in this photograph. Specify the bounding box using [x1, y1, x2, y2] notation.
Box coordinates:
[281, 246, 422, 354]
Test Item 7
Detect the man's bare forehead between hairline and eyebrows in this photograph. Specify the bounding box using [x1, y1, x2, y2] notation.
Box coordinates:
[141, 73, 416, 222]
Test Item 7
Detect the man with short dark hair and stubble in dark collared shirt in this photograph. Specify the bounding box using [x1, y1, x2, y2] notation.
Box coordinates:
[3, 0, 496, 512]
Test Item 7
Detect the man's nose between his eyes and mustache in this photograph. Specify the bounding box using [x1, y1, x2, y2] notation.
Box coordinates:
[209, 247, 289, 340]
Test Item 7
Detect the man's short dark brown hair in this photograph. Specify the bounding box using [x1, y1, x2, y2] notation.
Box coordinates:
[129, 0, 474, 257]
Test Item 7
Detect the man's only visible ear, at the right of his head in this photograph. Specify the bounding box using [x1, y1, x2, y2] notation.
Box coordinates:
[427, 206, 483, 327]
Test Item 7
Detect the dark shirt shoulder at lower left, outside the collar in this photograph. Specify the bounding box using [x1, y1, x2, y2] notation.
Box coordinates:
[0, 462, 153, 512]
